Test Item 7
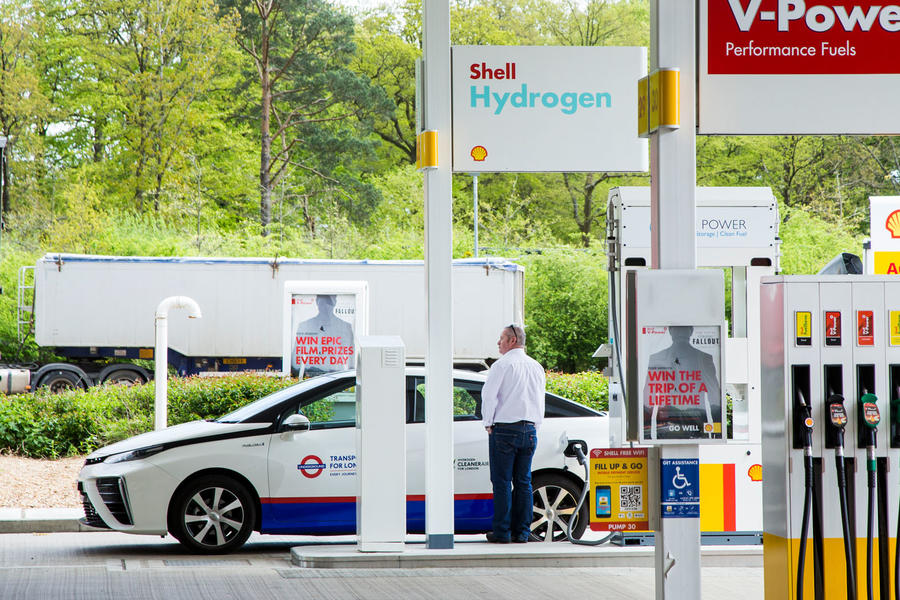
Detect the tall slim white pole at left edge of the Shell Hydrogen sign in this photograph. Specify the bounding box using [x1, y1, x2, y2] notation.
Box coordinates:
[422, 0, 453, 549]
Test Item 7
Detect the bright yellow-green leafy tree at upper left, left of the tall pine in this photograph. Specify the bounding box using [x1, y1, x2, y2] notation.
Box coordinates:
[57, 0, 239, 211]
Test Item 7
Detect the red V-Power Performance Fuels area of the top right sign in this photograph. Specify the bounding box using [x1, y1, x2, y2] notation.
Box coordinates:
[701, 0, 900, 75]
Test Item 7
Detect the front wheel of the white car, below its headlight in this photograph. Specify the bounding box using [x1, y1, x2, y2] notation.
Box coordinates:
[169, 475, 256, 554]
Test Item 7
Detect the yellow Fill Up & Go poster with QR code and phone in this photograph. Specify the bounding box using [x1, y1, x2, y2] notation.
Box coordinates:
[590, 448, 650, 531]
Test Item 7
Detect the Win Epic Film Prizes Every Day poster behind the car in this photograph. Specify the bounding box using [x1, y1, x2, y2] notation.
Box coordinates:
[291, 294, 357, 378]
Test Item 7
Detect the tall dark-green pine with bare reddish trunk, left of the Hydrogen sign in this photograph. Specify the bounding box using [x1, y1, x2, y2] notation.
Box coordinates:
[224, 0, 390, 235]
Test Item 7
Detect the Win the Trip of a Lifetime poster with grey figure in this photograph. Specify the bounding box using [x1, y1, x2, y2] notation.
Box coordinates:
[638, 325, 724, 440]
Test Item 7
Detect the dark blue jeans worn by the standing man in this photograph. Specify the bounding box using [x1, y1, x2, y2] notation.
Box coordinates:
[488, 421, 537, 540]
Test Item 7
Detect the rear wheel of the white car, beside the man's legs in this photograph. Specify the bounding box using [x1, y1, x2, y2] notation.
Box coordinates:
[531, 473, 588, 542]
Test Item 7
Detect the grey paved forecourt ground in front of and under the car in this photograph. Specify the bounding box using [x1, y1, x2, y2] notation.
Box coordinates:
[0, 533, 763, 600]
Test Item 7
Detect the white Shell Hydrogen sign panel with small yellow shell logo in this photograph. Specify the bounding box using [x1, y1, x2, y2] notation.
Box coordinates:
[451, 46, 649, 173]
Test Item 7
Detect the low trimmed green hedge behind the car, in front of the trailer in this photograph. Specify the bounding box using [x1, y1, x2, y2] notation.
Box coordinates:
[0, 373, 606, 458]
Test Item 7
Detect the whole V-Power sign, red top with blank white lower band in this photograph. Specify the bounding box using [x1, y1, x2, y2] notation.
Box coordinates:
[698, 0, 900, 134]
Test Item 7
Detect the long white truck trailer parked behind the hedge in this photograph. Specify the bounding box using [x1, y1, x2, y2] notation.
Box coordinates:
[0, 254, 524, 392]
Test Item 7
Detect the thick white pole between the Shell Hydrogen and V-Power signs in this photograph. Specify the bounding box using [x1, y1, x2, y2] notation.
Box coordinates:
[650, 0, 701, 600]
